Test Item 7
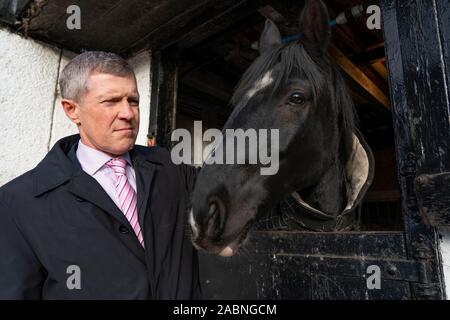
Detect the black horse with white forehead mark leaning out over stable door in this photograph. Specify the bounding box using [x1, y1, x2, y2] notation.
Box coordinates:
[190, 1, 373, 256]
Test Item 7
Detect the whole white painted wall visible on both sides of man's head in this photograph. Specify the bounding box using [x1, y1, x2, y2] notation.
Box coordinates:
[0, 28, 151, 186]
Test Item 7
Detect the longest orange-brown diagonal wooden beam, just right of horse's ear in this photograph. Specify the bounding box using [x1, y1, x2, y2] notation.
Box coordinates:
[329, 45, 390, 109]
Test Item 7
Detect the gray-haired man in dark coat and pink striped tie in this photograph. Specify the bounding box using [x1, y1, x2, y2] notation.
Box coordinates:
[0, 52, 200, 299]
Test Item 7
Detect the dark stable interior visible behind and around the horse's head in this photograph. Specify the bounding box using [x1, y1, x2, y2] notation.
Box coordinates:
[176, 1, 403, 231]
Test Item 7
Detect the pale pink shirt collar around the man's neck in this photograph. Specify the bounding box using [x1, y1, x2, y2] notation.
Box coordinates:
[76, 139, 132, 175]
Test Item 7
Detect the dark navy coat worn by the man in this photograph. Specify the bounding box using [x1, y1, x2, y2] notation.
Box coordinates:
[0, 135, 200, 299]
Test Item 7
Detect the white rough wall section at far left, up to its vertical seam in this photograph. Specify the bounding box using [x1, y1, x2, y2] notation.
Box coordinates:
[0, 29, 60, 185]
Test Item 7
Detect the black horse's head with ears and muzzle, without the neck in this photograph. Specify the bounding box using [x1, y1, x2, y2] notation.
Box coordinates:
[190, 1, 353, 255]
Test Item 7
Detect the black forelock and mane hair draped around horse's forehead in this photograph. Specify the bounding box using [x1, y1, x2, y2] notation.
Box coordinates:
[228, 42, 355, 149]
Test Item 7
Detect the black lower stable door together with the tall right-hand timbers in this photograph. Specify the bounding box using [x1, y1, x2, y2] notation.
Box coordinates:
[200, 0, 450, 299]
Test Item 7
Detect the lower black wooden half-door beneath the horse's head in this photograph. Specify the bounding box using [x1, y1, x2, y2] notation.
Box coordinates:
[200, 231, 420, 300]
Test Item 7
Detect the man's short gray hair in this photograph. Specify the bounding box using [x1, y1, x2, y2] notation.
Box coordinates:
[59, 51, 136, 101]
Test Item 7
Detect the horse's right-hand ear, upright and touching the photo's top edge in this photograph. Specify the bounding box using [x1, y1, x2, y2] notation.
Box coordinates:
[300, 0, 331, 55]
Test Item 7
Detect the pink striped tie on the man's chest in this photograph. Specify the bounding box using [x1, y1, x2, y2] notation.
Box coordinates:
[106, 157, 144, 247]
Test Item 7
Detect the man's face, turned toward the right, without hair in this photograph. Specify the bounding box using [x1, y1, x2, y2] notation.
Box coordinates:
[77, 73, 139, 156]
